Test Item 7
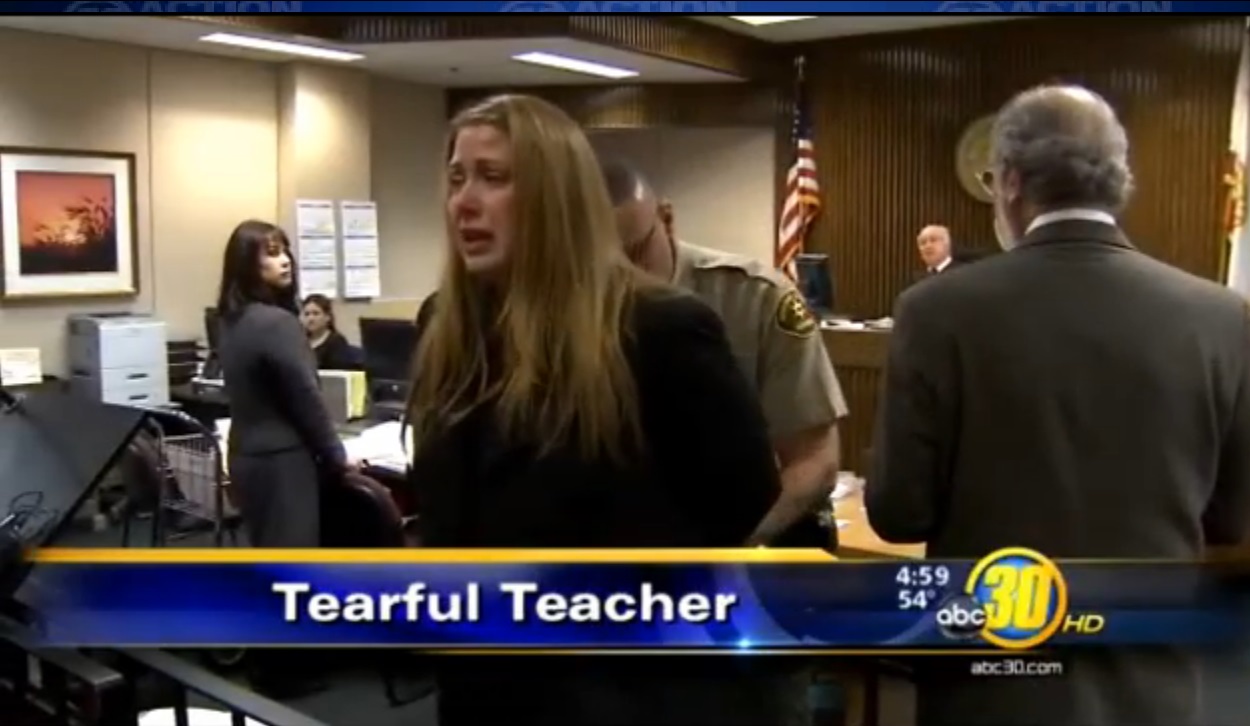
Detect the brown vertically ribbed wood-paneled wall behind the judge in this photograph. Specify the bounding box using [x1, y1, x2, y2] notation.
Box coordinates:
[806, 15, 1244, 316]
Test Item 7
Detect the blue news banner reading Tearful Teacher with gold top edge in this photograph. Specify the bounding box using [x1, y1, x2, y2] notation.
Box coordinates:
[19, 549, 1250, 655]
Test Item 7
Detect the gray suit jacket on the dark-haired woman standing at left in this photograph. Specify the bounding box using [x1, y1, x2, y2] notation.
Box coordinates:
[221, 302, 345, 466]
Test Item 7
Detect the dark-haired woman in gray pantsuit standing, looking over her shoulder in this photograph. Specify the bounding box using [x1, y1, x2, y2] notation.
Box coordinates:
[218, 220, 348, 696]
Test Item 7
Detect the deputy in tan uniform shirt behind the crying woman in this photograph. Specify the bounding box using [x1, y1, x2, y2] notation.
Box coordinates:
[604, 162, 846, 546]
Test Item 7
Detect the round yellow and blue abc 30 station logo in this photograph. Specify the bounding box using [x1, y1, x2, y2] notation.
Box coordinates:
[936, 547, 1068, 650]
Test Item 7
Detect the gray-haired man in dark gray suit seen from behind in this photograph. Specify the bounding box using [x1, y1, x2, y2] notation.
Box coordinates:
[865, 86, 1250, 726]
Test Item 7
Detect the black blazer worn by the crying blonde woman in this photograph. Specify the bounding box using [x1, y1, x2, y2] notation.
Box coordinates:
[413, 292, 780, 726]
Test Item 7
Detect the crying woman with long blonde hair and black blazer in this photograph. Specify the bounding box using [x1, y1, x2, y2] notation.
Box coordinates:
[408, 96, 783, 726]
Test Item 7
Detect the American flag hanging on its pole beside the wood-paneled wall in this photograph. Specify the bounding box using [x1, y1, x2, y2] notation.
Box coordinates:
[774, 57, 820, 279]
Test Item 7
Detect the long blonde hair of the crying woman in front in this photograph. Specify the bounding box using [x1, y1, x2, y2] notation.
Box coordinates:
[408, 95, 649, 460]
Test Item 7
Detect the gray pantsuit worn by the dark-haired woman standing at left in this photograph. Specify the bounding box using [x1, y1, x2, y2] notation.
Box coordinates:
[220, 302, 346, 547]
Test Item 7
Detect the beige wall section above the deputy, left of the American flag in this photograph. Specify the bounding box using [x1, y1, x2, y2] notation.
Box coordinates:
[591, 129, 776, 264]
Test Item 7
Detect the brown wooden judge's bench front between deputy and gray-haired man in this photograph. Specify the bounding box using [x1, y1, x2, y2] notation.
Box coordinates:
[823, 330, 890, 472]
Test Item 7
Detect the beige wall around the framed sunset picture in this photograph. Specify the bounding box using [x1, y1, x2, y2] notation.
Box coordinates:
[0, 30, 445, 375]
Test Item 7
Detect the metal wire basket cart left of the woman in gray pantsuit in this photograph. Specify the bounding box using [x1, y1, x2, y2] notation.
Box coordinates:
[123, 409, 239, 547]
